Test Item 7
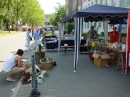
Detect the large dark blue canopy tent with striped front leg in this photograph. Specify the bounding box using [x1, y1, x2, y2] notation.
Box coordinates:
[72, 4, 130, 72]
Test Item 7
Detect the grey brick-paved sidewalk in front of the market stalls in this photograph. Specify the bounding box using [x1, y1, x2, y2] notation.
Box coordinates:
[12, 51, 130, 97]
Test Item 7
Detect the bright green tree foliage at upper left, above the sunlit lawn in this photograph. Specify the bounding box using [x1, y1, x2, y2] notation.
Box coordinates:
[0, 0, 44, 29]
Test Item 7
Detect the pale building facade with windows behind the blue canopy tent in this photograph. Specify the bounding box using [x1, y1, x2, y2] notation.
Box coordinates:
[66, 0, 130, 34]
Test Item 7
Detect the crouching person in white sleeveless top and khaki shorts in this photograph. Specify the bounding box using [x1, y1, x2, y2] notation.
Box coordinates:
[2, 49, 26, 81]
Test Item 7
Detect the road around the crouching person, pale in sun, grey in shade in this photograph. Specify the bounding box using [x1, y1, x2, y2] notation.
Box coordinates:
[0, 32, 33, 97]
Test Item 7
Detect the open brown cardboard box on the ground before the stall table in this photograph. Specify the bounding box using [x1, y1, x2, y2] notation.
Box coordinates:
[93, 53, 110, 67]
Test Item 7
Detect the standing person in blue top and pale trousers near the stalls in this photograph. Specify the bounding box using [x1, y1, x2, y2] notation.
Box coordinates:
[33, 29, 41, 49]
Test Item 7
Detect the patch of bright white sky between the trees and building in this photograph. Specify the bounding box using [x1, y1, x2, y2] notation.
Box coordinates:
[38, 0, 65, 14]
